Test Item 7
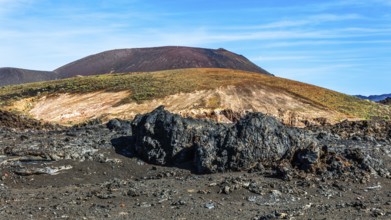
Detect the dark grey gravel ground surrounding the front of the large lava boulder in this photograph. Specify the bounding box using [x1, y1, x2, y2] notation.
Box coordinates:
[0, 116, 391, 219]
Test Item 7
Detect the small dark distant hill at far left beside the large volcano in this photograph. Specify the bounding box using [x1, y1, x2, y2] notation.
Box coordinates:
[0, 67, 58, 86]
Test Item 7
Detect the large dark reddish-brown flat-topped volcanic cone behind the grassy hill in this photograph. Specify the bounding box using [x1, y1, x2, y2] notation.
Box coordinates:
[54, 46, 270, 78]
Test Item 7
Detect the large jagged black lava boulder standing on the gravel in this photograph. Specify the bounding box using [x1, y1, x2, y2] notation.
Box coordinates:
[132, 106, 317, 173]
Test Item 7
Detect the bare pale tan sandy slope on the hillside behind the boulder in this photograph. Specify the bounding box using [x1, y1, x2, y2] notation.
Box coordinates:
[14, 86, 346, 126]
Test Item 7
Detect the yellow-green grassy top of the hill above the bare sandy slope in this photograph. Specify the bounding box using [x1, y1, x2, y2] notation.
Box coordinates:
[0, 68, 391, 119]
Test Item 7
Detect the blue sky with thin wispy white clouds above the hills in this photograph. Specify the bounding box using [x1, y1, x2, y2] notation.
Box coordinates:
[0, 0, 391, 95]
